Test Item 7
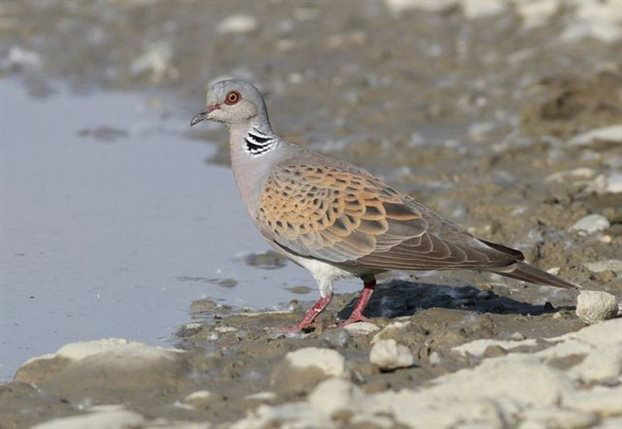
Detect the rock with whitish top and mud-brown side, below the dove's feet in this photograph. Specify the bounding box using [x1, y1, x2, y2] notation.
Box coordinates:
[271, 347, 348, 392]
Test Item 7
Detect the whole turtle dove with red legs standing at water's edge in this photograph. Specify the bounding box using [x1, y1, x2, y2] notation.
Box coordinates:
[190, 79, 579, 331]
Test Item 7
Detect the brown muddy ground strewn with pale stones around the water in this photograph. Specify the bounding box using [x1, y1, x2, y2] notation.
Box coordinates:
[0, 0, 622, 429]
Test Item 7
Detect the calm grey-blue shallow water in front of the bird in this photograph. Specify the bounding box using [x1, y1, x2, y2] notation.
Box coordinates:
[0, 79, 357, 381]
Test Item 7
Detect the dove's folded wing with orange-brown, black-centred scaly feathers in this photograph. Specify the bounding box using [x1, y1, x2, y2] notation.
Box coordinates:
[256, 156, 522, 270]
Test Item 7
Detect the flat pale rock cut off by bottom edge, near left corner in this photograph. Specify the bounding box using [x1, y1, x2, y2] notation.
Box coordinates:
[32, 405, 145, 429]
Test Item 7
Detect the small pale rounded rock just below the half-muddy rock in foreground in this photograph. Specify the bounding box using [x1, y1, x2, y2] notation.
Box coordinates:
[307, 378, 363, 415]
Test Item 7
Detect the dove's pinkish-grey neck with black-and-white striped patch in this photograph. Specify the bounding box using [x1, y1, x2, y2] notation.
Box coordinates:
[229, 119, 280, 216]
